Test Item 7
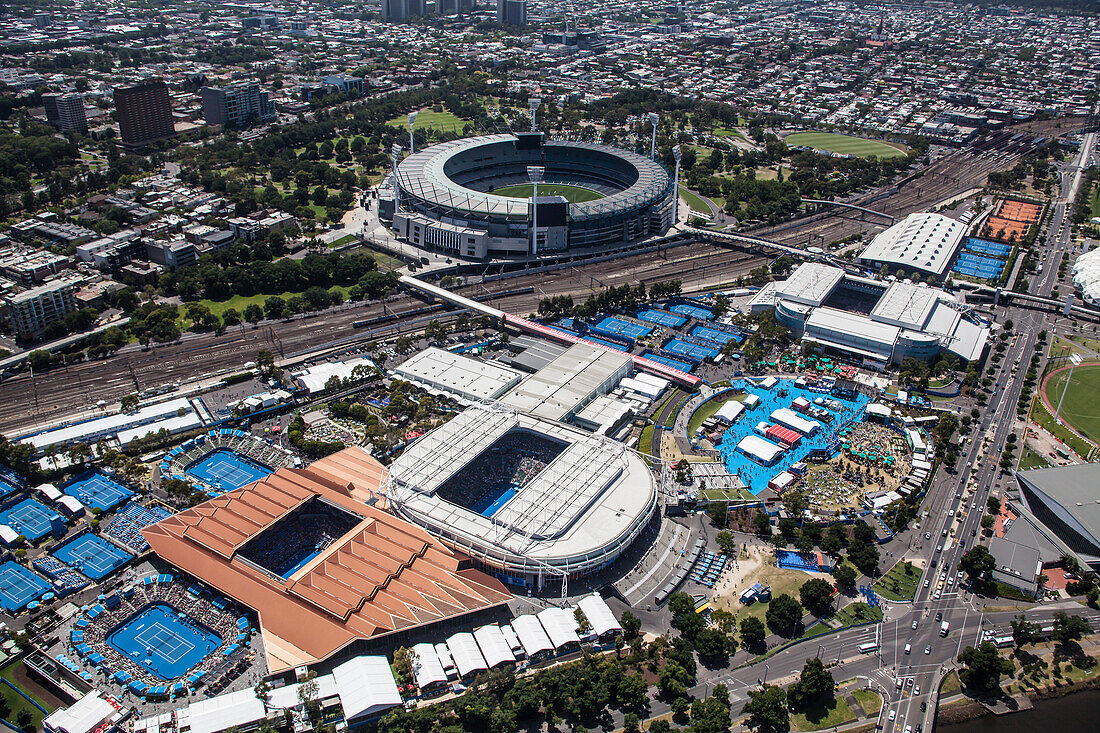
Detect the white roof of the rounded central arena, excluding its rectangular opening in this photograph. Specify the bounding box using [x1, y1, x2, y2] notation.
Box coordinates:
[386, 405, 656, 572]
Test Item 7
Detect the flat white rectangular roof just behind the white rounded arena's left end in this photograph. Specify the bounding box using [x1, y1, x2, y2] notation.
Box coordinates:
[394, 347, 524, 402]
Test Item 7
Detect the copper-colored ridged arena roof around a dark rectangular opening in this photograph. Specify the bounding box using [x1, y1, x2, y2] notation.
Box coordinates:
[142, 448, 512, 671]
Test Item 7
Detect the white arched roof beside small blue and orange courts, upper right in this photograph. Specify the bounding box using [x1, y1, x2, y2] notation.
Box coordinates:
[859, 214, 966, 277]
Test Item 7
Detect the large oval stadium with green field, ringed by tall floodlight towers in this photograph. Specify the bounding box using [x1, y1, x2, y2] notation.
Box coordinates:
[380, 132, 674, 260]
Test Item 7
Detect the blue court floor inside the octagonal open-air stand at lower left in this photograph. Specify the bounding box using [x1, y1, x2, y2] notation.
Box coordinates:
[107, 603, 221, 680]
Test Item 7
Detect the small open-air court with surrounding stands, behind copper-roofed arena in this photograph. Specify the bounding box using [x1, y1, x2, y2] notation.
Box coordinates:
[161, 428, 296, 496]
